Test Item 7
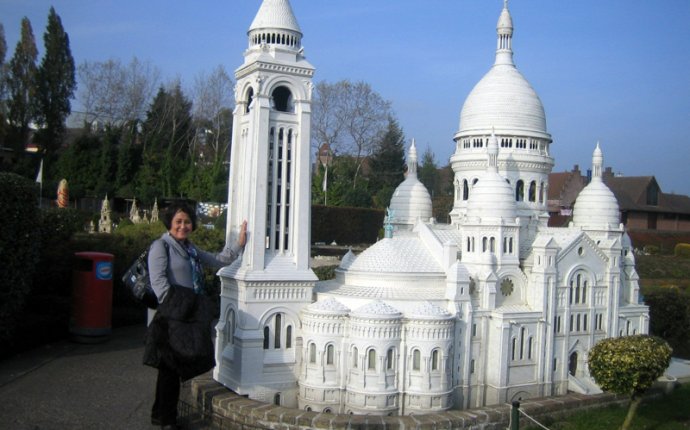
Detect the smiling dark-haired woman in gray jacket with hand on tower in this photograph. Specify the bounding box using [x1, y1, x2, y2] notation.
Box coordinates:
[144, 203, 247, 429]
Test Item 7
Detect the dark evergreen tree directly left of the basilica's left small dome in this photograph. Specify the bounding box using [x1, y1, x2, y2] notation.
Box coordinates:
[369, 117, 405, 208]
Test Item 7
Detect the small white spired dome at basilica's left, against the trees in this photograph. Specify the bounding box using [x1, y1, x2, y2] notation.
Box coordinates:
[389, 140, 432, 225]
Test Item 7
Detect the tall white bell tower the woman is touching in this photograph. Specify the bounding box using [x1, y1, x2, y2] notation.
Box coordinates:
[214, 0, 317, 406]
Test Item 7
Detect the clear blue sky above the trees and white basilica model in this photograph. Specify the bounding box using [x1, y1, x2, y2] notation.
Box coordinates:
[0, 0, 690, 195]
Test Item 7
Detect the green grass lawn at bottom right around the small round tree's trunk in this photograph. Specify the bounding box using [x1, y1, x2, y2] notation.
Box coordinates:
[524, 384, 690, 430]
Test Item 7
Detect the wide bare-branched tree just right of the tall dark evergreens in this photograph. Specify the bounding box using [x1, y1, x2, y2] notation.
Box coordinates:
[78, 58, 160, 125]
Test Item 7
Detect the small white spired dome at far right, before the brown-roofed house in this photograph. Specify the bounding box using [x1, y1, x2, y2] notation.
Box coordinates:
[573, 143, 620, 228]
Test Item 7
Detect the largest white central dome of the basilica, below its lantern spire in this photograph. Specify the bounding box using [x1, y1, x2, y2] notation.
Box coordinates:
[459, 64, 550, 138]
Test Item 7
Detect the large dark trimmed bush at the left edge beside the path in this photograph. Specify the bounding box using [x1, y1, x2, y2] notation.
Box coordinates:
[0, 172, 41, 343]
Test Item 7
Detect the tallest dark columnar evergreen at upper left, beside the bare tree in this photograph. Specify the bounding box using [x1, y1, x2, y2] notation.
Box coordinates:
[35, 7, 77, 154]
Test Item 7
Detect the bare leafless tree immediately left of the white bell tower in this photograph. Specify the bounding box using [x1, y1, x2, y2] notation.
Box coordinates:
[192, 65, 233, 162]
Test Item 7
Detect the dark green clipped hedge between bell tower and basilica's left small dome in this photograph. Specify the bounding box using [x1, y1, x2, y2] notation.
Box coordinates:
[311, 205, 385, 245]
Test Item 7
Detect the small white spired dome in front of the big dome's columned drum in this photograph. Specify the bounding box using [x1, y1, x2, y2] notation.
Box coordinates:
[467, 134, 517, 220]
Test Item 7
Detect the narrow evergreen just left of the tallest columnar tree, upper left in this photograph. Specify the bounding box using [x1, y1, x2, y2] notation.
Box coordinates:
[6, 17, 38, 154]
